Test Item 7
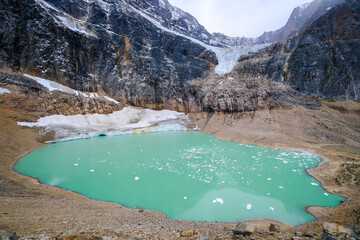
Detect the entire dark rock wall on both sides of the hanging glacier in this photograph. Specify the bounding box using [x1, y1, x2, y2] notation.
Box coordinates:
[0, 0, 360, 112]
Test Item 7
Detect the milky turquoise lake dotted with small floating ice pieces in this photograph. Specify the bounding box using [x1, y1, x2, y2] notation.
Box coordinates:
[14, 131, 343, 225]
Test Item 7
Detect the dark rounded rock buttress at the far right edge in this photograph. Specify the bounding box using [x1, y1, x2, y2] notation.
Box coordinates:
[284, 1, 360, 100]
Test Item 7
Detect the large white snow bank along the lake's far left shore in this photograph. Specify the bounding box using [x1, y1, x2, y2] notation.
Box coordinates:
[18, 107, 196, 142]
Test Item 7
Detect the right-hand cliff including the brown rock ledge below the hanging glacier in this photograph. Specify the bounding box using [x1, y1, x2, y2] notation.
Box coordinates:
[195, 0, 360, 112]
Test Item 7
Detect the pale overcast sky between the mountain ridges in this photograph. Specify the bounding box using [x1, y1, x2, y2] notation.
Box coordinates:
[169, 0, 311, 37]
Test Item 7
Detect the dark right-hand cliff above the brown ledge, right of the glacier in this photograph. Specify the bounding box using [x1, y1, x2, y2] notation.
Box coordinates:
[229, 0, 360, 100]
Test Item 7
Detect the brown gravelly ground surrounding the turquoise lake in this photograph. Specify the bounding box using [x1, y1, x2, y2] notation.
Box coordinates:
[0, 76, 360, 239]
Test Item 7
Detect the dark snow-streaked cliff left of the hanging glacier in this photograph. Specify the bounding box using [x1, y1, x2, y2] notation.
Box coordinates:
[0, 0, 217, 110]
